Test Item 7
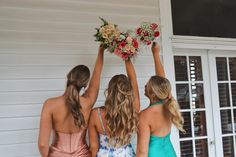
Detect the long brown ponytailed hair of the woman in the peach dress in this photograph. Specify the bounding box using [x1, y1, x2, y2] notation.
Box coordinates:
[65, 65, 90, 128]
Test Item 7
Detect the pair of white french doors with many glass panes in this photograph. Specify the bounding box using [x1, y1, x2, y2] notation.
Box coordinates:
[174, 49, 236, 157]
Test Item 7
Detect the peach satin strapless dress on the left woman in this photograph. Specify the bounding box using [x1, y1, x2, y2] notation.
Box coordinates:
[48, 130, 91, 157]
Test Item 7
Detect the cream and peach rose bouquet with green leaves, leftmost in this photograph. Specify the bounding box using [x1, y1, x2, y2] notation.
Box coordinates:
[94, 17, 120, 49]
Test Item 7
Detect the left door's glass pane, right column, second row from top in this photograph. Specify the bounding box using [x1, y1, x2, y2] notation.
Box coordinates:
[191, 83, 205, 109]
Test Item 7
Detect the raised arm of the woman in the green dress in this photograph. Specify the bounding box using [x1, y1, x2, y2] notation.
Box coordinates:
[152, 42, 165, 77]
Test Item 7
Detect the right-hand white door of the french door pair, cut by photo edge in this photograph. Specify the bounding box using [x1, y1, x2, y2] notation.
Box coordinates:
[209, 51, 236, 157]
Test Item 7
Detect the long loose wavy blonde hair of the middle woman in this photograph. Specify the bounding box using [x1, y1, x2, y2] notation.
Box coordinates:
[105, 74, 138, 146]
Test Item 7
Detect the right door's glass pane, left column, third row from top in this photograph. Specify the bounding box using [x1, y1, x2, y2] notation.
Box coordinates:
[220, 110, 233, 134]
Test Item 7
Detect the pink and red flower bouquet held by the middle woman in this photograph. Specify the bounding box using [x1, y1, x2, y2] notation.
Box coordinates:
[109, 33, 139, 60]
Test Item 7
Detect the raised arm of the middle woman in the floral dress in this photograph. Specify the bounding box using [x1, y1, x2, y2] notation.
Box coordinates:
[125, 60, 140, 112]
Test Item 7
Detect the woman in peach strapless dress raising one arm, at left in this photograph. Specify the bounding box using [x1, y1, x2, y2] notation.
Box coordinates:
[38, 46, 104, 157]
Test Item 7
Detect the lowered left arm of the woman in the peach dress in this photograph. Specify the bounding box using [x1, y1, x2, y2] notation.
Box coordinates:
[38, 101, 52, 157]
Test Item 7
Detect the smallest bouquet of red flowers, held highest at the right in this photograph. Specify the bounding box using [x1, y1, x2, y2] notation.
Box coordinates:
[136, 22, 160, 45]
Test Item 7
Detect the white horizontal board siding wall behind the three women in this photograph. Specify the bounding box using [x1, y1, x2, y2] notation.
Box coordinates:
[0, 0, 159, 157]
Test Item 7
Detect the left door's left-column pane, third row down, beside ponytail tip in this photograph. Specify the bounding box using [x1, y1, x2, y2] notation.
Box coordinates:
[180, 112, 192, 138]
